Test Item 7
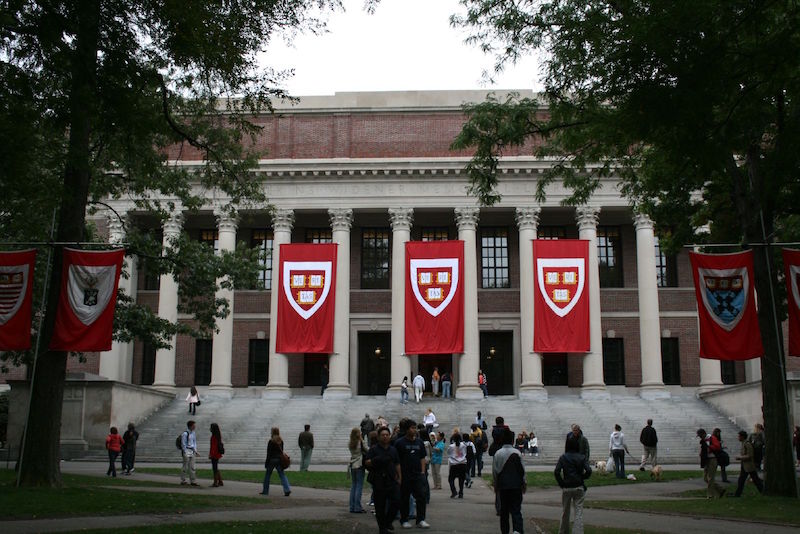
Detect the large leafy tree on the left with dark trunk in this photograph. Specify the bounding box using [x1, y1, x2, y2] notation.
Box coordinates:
[0, 0, 340, 486]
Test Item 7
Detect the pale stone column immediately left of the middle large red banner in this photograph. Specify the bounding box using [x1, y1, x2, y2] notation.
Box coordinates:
[386, 208, 414, 398]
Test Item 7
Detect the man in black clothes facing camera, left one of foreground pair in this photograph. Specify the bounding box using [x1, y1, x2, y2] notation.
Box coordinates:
[364, 426, 408, 534]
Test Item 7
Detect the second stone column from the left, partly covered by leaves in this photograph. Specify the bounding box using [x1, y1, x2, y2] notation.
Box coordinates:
[153, 207, 183, 391]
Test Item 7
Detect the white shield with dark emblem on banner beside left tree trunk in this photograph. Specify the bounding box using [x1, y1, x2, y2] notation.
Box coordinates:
[67, 264, 117, 326]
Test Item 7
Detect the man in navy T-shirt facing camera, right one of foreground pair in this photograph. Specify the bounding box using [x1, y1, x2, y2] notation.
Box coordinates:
[394, 422, 430, 528]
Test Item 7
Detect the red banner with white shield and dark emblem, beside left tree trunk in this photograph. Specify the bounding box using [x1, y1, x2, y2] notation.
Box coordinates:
[50, 248, 125, 352]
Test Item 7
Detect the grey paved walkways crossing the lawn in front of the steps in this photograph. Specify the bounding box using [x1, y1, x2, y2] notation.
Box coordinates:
[0, 462, 797, 534]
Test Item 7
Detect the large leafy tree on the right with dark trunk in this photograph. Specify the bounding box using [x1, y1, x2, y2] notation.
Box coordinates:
[452, 0, 800, 496]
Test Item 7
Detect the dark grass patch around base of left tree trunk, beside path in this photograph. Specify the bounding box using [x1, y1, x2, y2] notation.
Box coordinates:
[0, 469, 268, 519]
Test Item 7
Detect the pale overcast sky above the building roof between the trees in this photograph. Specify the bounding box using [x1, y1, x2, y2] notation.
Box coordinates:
[264, 0, 540, 96]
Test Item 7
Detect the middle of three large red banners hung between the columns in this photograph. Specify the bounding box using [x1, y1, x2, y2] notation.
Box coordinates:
[405, 241, 464, 354]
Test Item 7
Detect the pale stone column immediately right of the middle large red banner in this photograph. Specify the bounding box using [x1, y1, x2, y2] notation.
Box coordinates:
[455, 207, 482, 399]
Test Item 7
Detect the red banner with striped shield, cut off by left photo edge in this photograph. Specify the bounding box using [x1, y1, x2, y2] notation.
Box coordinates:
[0, 250, 36, 350]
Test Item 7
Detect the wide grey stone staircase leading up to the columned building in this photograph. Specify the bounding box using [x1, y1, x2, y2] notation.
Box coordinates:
[69, 389, 739, 464]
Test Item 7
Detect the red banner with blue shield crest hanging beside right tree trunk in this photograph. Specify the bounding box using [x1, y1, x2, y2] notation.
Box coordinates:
[689, 251, 764, 360]
